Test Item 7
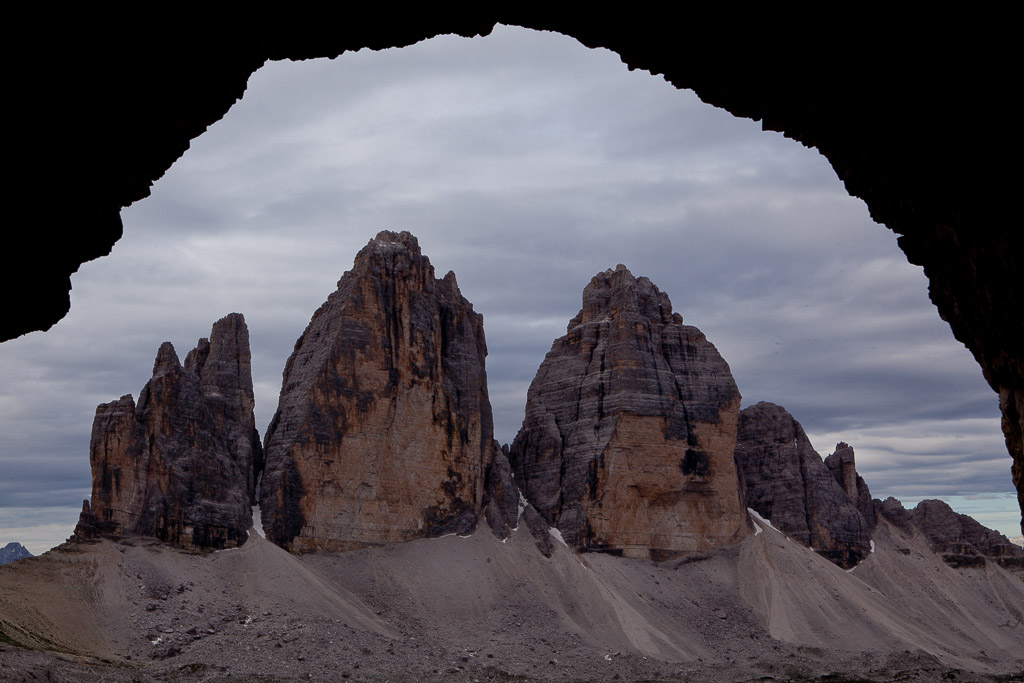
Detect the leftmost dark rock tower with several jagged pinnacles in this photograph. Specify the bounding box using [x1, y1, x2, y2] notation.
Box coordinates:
[75, 313, 260, 549]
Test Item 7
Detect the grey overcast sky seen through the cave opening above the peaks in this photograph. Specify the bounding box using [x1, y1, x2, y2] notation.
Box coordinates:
[0, 28, 1019, 553]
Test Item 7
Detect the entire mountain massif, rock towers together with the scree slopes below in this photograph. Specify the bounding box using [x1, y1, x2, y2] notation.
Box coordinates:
[0, 231, 1024, 683]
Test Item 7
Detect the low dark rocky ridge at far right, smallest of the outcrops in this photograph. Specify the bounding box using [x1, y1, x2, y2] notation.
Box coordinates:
[877, 498, 1024, 571]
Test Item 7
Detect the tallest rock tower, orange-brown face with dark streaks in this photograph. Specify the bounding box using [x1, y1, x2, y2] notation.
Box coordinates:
[260, 231, 494, 552]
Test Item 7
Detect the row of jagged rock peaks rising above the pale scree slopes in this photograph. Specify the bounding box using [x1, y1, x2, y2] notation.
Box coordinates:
[75, 231, 1024, 569]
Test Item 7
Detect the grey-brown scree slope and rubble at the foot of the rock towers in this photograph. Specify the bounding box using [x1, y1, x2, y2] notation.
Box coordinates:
[0, 523, 1024, 681]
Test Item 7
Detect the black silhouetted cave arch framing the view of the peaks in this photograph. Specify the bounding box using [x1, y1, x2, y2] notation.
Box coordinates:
[6, 12, 1024, 529]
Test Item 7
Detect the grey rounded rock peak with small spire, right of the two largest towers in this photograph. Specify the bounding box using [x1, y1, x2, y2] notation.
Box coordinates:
[736, 401, 873, 568]
